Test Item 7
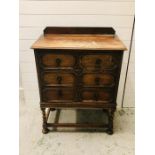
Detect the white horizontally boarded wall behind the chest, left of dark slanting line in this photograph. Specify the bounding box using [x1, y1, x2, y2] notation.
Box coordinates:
[19, 0, 134, 107]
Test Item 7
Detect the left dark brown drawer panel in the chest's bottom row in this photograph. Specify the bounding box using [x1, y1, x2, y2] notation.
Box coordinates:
[42, 88, 74, 102]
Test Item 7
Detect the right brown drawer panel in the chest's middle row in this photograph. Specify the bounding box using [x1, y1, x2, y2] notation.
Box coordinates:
[82, 73, 115, 87]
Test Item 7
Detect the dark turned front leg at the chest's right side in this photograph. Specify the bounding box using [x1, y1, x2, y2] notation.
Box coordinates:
[106, 109, 114, 135]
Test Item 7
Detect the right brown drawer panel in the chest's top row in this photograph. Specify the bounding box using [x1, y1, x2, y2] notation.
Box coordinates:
[81, 54, 117, 70]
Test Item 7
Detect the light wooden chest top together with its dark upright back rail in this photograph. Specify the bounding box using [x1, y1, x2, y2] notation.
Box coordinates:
[31, 27, 126, 51]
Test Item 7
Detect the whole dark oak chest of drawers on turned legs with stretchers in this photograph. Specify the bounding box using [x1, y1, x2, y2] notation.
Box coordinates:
[32, 27, 126, 134]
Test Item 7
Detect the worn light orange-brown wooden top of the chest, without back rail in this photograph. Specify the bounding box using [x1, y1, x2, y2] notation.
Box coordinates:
[31, 34, 127, 51]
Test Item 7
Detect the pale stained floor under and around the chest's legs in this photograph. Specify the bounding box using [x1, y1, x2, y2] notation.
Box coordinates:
[20, 103, 134, 155]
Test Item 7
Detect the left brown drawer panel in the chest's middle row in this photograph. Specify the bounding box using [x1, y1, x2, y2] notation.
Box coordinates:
[42, 72, 75, 86]
